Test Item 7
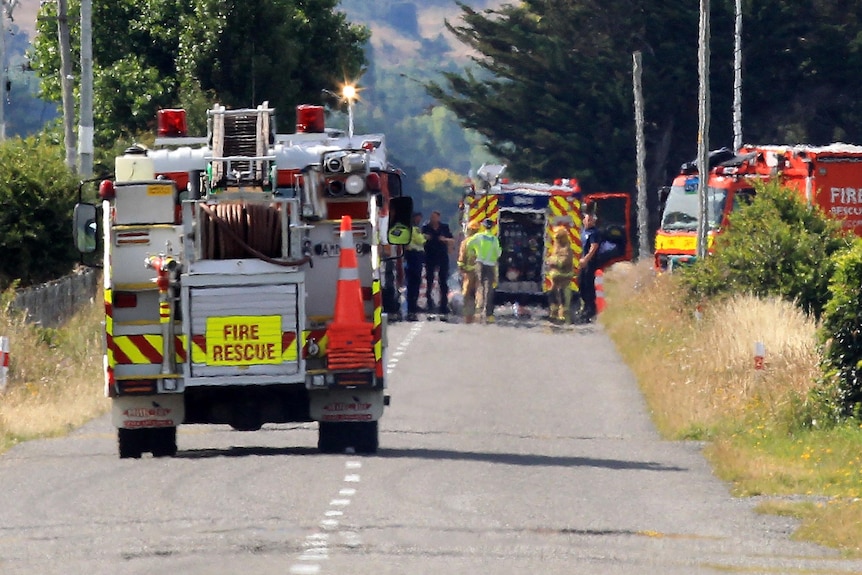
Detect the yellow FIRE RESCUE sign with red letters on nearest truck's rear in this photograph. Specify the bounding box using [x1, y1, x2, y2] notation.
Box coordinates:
[206, 315, 282, 365]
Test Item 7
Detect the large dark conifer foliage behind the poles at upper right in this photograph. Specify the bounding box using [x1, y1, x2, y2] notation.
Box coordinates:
[429, 0, 862, 196]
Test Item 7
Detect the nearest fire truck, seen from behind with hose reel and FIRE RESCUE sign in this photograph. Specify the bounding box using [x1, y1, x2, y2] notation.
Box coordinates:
[74, 100, 412, 458]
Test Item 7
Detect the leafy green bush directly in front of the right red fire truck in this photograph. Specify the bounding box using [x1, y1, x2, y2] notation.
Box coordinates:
[683, 181, 851, 318]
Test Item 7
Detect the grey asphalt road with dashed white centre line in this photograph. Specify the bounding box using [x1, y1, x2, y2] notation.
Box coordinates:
[0, 321, 862, 575]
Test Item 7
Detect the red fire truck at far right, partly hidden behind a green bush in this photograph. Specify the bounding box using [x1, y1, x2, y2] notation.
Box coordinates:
[655, 143, 862, 270]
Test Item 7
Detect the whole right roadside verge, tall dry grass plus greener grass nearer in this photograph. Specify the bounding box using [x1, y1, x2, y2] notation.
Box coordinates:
[601, 264, 862, 556]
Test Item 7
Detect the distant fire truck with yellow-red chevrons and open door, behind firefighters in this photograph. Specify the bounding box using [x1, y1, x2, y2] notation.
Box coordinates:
[459, 165, 632, 305]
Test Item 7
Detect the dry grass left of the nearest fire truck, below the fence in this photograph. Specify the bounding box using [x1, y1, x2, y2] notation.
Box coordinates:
[0, 290, 109, 452]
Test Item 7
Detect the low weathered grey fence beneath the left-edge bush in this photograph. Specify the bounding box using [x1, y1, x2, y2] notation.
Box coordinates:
[10, 268, 100, 327]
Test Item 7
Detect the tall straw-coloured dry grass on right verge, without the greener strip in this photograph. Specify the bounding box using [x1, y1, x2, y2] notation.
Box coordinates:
[603, 264, 818, 438]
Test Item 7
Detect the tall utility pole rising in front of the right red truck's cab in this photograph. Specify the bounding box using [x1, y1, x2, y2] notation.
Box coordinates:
[697, 0, 710, 259]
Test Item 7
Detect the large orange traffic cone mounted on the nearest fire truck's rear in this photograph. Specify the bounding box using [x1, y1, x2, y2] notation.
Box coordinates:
[327, 216, 375, 369]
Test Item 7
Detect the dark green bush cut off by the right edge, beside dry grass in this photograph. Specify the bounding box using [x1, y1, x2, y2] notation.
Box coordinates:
[821, 239, 862, 417]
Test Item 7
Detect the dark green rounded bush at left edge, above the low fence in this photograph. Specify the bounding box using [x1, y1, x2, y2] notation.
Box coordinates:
[0, 137, 78, 290]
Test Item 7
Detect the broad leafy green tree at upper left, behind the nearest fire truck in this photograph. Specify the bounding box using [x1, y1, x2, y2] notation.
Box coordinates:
[33, 0, 369, 146]
